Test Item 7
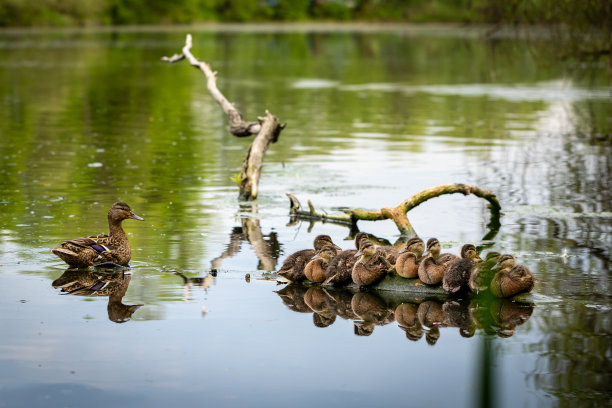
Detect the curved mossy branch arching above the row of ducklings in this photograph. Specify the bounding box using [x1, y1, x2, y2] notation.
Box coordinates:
[287, 184, 501, 236]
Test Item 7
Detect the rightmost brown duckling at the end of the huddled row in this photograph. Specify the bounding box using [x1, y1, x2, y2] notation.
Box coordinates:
[490, 255, 535, 298]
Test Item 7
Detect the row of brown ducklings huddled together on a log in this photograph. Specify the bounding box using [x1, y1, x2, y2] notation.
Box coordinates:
[278, 232, 535, 297]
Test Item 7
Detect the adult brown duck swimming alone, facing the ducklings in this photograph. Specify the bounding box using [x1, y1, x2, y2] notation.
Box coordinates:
[52, 202, 144, 268]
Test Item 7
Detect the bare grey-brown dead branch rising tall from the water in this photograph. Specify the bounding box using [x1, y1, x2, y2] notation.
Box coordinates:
[162, 34, 285, 201]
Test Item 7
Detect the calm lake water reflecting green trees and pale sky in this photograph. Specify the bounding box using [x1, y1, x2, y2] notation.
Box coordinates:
[0, 26, 612, 407]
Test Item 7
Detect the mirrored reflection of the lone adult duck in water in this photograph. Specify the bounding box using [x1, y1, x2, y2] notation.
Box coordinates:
[52, 269, 143, 323]
